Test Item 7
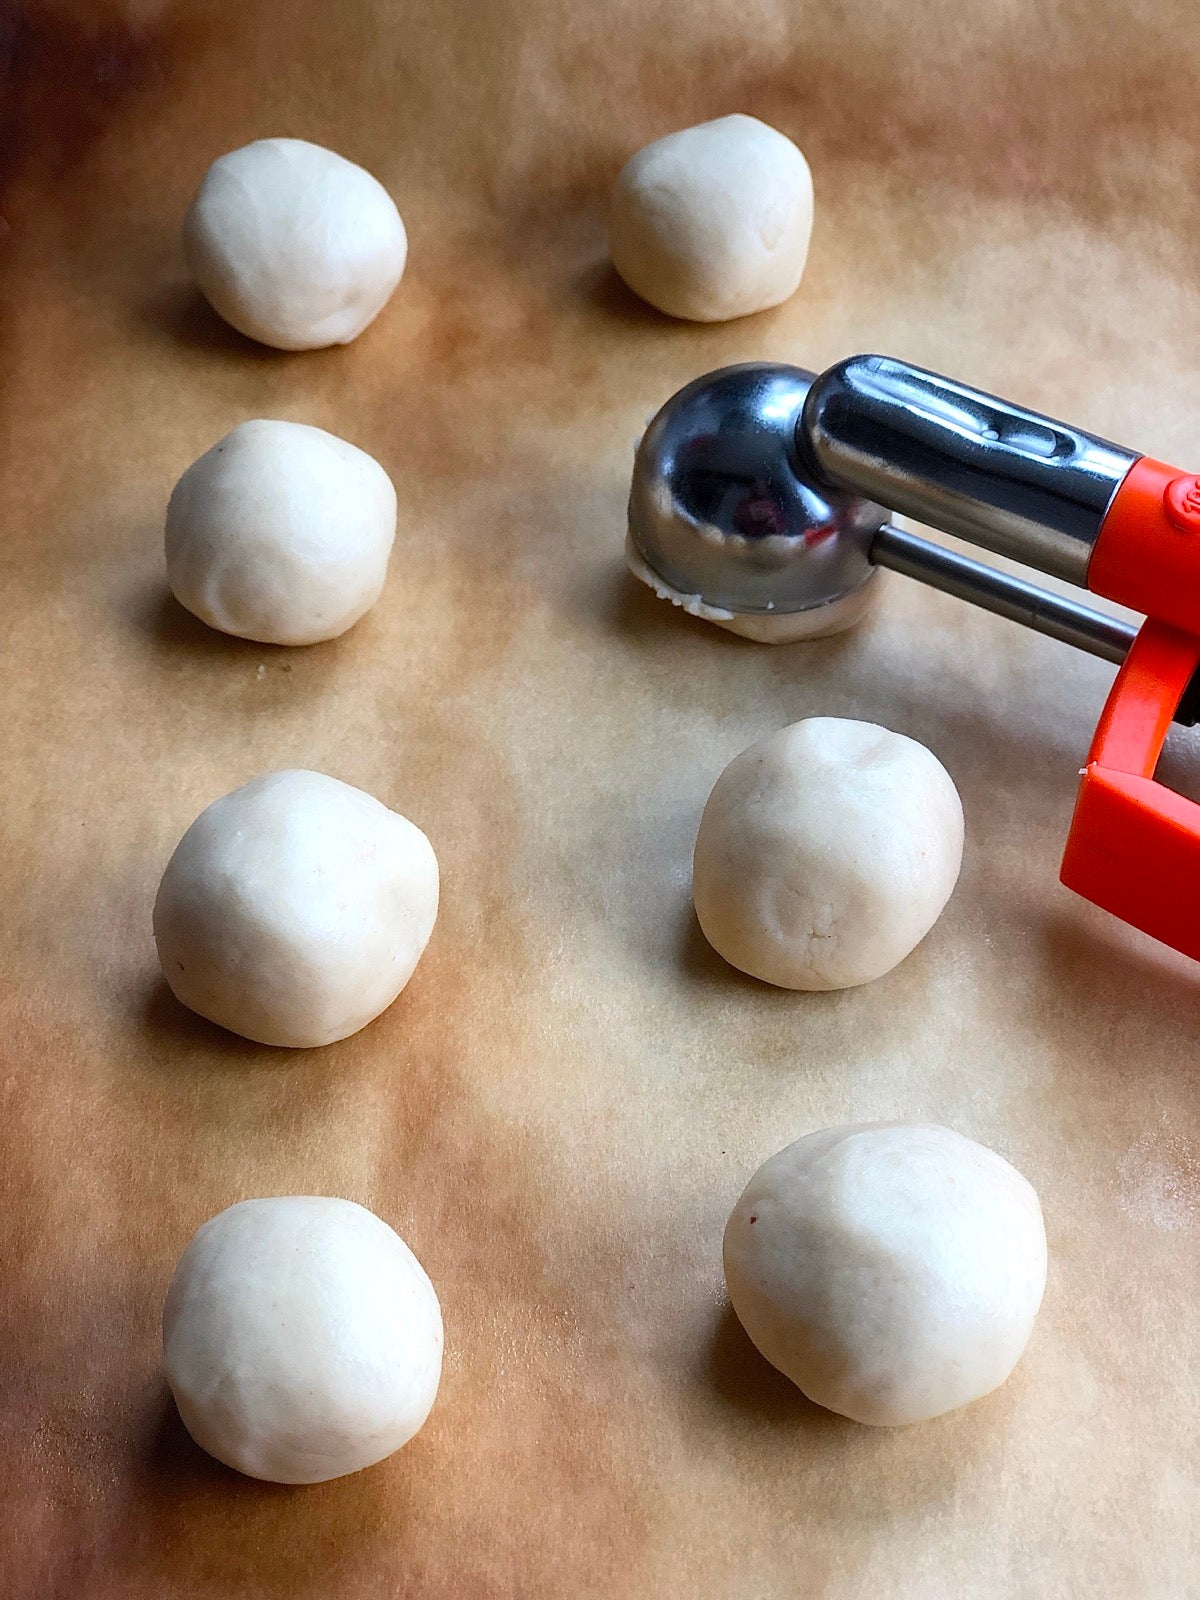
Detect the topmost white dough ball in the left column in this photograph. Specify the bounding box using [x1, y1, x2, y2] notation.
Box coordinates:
[184, 139, 408, 350]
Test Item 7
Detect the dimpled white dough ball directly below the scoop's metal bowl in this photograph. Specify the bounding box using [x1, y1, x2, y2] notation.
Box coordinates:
[691, 717, 963, 989]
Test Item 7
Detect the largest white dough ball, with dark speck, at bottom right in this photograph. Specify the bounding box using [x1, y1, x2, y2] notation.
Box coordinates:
[725, 1122, 1046, 1427]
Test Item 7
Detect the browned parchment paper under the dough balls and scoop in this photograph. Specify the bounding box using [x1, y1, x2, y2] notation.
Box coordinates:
[0, 0, 1200, 1600]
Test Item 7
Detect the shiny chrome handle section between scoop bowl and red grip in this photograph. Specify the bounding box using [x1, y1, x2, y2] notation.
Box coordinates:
[797, 355, 1139, 588]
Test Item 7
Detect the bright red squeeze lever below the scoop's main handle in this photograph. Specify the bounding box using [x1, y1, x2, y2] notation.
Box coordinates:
[1061, 617, 1200, 960]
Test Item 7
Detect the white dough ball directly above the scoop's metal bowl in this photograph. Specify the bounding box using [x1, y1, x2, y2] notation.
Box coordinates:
[608, 115, 813, 322]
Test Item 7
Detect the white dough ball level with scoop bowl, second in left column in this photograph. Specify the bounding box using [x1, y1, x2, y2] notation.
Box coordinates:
[166, 421, 395, 645]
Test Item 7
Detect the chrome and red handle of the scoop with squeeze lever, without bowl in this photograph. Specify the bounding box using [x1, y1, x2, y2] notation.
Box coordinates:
[798, 355, 1200, 960]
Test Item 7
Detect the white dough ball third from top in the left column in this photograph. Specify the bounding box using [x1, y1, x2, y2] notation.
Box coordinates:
[154, 771, 438, 1048]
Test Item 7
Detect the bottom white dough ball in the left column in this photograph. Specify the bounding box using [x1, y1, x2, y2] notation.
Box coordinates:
[163, 1195, 442, 1483]
